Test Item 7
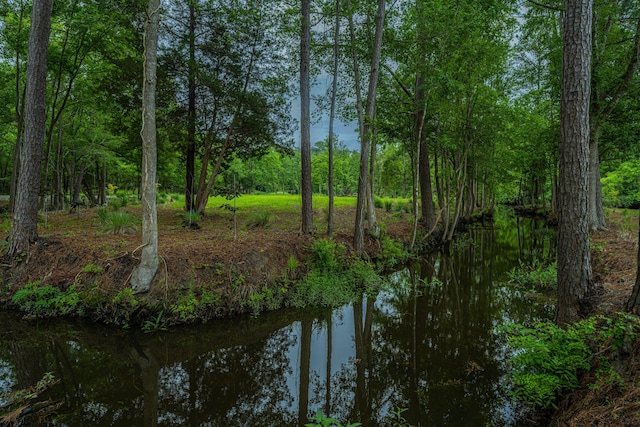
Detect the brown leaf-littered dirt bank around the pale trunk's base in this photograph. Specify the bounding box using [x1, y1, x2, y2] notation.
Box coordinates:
[0, 206, 411, 324]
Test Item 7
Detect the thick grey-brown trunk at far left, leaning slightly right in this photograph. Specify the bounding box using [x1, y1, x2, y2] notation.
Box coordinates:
[7, 0, 53, 257]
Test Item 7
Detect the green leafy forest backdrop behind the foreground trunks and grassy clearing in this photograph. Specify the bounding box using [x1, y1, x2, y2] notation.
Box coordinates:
[0, 0, 640, 224]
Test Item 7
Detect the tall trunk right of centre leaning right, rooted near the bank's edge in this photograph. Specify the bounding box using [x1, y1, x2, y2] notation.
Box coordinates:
[353, 0, 386, 255]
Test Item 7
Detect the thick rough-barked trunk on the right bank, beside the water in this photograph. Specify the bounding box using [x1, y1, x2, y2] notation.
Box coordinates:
[556, 0, 594, 325]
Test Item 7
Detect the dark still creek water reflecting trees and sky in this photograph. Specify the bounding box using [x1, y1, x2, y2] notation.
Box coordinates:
[0, 216, 554, 426]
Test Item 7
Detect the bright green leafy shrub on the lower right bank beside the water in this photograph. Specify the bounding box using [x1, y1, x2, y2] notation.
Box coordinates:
[502, 313, 640, 408]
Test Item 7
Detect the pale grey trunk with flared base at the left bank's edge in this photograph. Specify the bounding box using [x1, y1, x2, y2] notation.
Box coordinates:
[131, 0, 160, 293]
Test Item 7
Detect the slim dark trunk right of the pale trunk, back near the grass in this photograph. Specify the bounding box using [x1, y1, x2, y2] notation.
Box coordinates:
[184, 2, 196, 212]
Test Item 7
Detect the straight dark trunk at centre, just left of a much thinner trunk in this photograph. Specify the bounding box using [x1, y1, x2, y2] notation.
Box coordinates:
[300, 0, 313, 234]
